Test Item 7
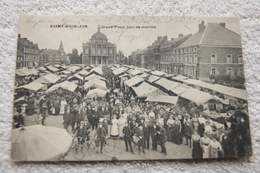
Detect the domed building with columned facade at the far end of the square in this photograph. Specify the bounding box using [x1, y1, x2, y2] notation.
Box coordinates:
[82, 27, 117, 65]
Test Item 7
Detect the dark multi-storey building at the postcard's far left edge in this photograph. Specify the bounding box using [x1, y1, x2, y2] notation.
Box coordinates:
[16, 34, 39, 69]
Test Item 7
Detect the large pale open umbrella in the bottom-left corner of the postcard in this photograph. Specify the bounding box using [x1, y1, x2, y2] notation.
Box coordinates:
[11, 125, 72, 161]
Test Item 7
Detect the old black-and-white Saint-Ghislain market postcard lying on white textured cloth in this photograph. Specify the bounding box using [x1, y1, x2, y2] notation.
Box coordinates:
[11, 15, 252, 161]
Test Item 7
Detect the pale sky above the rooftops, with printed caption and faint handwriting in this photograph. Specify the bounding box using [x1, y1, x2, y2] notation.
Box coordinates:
[18, 15, 240, 56]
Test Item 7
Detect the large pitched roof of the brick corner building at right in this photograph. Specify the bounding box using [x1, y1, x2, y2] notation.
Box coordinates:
[178, 23, 241, 48]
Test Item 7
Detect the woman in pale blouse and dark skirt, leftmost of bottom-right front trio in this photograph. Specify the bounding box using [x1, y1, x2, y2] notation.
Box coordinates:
[191, 131, 202, 159]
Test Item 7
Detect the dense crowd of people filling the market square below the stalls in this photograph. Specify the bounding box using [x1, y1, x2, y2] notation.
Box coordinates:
[14, 67, 251, 159]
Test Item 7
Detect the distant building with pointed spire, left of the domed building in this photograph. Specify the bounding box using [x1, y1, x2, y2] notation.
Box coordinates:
[39, 41, 69, 66]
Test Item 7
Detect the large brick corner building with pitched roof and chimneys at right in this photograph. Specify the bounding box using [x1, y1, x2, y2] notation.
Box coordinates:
[175, 21, 244, 81]
